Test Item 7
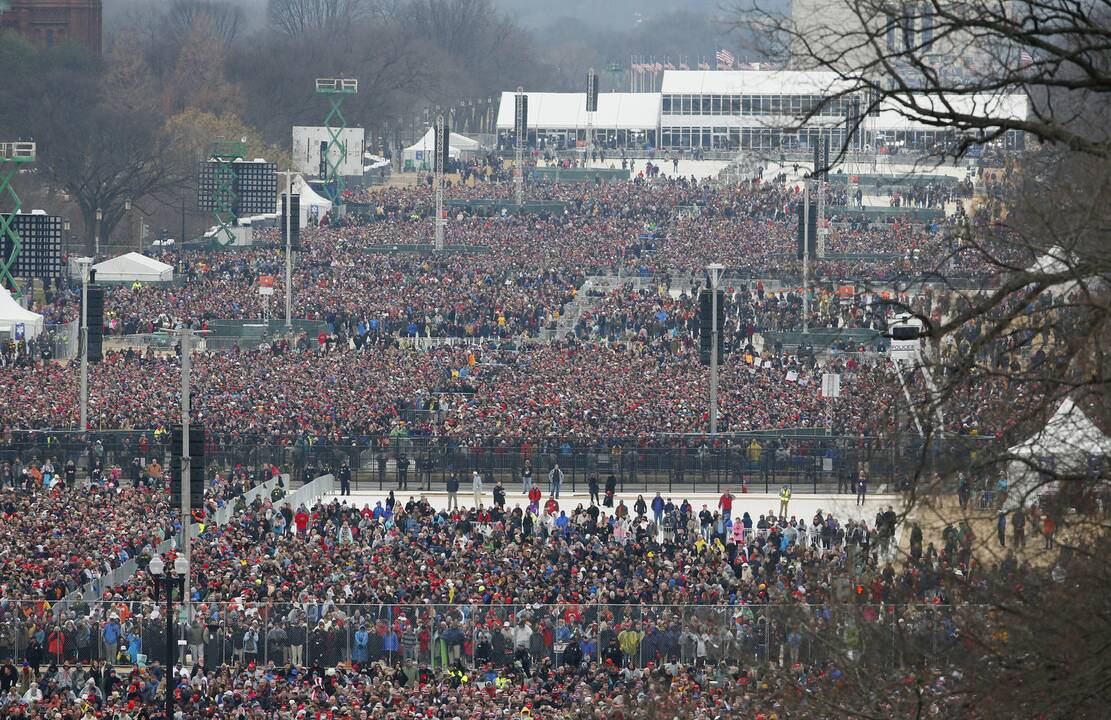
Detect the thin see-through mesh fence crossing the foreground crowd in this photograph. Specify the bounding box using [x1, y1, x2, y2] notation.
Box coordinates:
[0, 601, 968, 668]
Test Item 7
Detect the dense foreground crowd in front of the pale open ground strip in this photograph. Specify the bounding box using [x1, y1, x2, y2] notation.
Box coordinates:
[0, 477, 1031, 720]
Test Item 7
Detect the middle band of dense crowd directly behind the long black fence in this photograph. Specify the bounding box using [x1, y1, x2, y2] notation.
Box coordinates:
[0, 336, 887, 444]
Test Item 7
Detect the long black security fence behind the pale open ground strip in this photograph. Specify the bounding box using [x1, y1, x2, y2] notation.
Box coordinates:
[0, 426, 994, 492]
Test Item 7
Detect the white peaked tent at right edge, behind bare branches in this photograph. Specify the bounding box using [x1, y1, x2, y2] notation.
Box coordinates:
[1007, 398, 1111, 504]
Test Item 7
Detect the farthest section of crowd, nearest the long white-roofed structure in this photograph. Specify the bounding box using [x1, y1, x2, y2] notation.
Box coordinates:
[28, 174, 984, 337]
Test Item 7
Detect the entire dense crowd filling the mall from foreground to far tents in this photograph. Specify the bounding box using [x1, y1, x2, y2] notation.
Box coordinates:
[0, 163, 1052, 720]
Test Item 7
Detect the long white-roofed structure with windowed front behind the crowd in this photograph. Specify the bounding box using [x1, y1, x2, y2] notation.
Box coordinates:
[497, 70, 1028, 153]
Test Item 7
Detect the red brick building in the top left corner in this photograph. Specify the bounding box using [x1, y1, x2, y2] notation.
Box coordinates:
[0, 0, 101, 54]
